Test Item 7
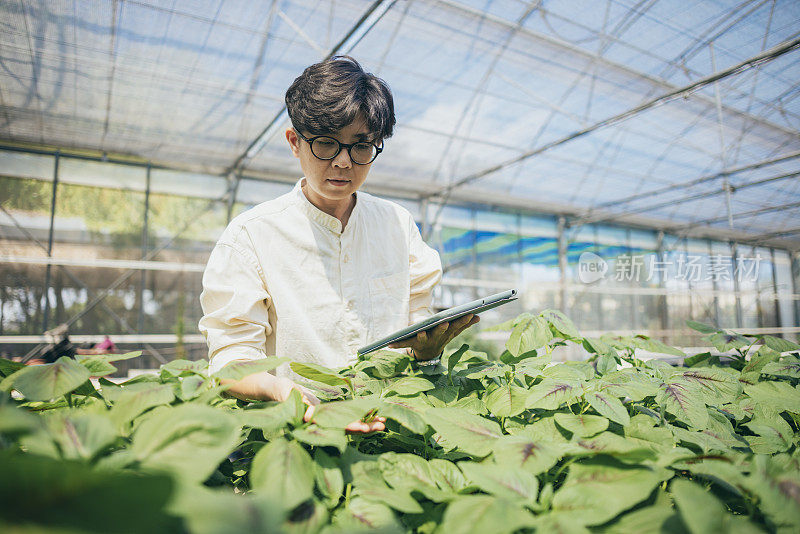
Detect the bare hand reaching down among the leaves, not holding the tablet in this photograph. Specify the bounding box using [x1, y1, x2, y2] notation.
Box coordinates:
[222, 372, 386, 433]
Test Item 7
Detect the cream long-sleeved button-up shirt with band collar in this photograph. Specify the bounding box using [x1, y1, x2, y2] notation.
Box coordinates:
[200, 180, 442, 378]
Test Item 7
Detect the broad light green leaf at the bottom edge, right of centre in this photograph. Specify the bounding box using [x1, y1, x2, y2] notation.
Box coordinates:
[553, 459, 669, 525]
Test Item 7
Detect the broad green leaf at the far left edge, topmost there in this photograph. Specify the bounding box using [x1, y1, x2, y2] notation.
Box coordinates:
[0, 356, 91, 401]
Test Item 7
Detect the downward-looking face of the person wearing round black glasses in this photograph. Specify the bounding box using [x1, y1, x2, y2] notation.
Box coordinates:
[286, 113, 372, 211]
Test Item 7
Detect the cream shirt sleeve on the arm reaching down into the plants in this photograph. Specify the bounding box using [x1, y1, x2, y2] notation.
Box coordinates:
[199, 233, 272, 374]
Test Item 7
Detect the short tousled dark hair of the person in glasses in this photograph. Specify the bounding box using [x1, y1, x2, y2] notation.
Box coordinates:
[286, 56, 395, 140]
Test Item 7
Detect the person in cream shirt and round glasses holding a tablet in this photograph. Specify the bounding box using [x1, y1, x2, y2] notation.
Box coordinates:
[200, 56, 478, 432]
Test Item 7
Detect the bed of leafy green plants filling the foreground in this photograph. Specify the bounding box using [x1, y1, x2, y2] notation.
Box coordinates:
[0, 310, 800, 533]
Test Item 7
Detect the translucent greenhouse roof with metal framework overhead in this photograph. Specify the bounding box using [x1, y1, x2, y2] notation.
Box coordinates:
[0, 0, 800, 248]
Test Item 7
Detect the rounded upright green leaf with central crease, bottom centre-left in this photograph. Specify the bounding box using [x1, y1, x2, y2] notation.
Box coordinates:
[250, 438, 314, 510]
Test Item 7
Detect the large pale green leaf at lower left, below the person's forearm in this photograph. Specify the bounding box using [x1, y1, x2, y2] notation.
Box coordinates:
[130, 404, 239, 483]
